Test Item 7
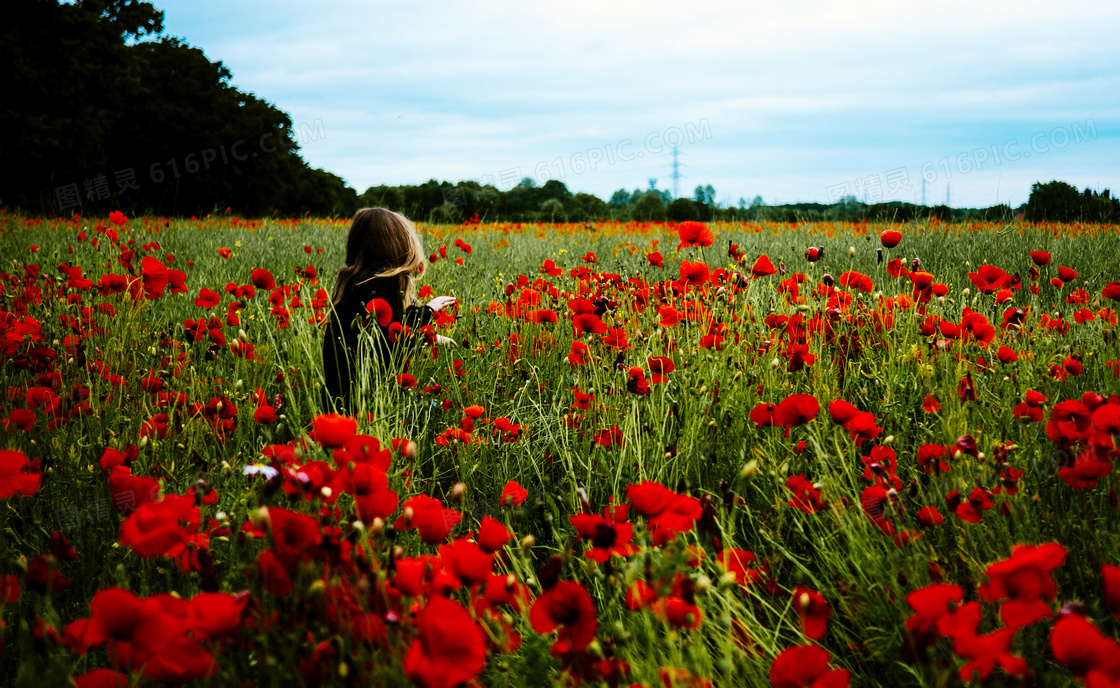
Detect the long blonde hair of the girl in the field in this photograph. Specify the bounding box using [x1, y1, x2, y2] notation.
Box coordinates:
[330, 207, 424, 307]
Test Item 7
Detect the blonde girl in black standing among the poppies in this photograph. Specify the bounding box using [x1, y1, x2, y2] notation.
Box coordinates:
[323, 207, 455, 415]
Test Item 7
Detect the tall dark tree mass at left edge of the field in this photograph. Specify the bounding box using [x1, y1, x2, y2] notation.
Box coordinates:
[0, 0, 357, 215]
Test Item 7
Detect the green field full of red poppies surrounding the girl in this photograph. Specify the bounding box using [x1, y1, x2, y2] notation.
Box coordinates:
[0, 213, 1120, 688]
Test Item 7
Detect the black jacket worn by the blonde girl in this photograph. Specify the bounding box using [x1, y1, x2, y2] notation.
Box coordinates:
[323, 276, 435, 415]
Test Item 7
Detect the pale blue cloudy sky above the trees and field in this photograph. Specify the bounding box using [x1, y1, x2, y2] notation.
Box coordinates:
[155, 0, 1120, 207]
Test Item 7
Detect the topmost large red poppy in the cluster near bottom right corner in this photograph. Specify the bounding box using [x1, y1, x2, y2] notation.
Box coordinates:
[979, 542, 1065, 627]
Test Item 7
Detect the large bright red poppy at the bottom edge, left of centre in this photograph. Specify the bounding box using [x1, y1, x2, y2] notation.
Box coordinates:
[404, 595, 486, 688]
